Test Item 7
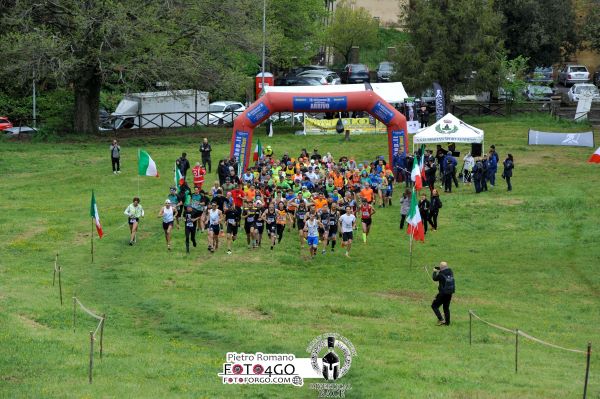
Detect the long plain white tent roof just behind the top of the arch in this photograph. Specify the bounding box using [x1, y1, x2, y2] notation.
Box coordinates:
[265, 82, 408, 103]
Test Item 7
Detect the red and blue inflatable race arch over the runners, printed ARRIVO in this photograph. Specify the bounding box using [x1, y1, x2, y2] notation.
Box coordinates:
[229, 91, 408, 170]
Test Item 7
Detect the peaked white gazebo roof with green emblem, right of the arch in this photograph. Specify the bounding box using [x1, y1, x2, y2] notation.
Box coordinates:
[413, 114, 483, 144]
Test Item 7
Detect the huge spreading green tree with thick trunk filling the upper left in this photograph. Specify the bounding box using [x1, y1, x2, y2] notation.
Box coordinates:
[0, 0, 262, 133]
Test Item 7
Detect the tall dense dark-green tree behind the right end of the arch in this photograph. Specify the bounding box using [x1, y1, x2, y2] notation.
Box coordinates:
[395, 0, 504, 98]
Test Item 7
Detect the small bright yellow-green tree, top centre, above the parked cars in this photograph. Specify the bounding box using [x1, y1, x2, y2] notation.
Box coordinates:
[327, 0, 378, 63]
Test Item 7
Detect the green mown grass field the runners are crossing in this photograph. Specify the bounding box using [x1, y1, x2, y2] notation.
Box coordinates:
[0, 117, 600, 398]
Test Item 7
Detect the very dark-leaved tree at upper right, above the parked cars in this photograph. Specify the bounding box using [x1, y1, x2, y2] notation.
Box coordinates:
[494, 0, 579, 67]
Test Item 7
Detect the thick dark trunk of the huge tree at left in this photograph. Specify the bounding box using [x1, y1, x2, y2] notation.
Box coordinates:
[74, 68, 101, 134]
